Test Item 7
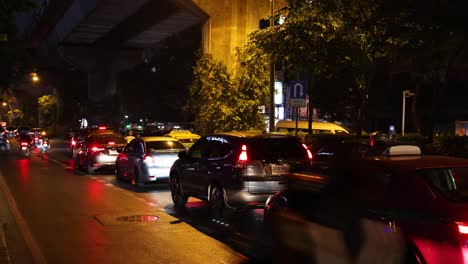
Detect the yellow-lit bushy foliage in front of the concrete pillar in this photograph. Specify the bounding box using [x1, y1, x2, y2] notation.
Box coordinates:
[185, 47, 268, 134]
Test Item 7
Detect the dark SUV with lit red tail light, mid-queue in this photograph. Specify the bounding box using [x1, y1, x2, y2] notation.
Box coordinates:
[170, 132, 312, 216]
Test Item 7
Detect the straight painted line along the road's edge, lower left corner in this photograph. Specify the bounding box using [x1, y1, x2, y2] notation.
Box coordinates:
[0, 172, 47, 264]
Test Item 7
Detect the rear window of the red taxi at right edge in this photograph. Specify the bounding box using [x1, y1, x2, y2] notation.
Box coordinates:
[418, 167, 468, 202]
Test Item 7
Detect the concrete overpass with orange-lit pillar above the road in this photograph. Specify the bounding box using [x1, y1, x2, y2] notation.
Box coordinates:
[24, 0, 284, 124]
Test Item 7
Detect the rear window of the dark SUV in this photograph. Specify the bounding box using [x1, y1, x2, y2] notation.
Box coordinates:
[249, 137, 307, 162]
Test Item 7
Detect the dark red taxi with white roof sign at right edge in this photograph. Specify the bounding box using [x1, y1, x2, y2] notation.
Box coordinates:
[264, 145, 468, 263]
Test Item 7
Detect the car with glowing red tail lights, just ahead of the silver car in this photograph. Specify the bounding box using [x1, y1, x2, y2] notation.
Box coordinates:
[75, 133, 127, 174]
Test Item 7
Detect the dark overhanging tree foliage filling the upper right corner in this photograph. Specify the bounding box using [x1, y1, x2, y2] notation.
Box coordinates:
[245, 0, 468, 136]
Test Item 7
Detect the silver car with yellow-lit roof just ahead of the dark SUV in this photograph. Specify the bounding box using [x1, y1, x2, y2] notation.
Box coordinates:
[115, 137, 186, 186]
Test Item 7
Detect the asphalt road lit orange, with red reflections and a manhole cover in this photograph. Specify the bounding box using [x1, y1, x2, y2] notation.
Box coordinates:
[0, 140, 269, 263]
